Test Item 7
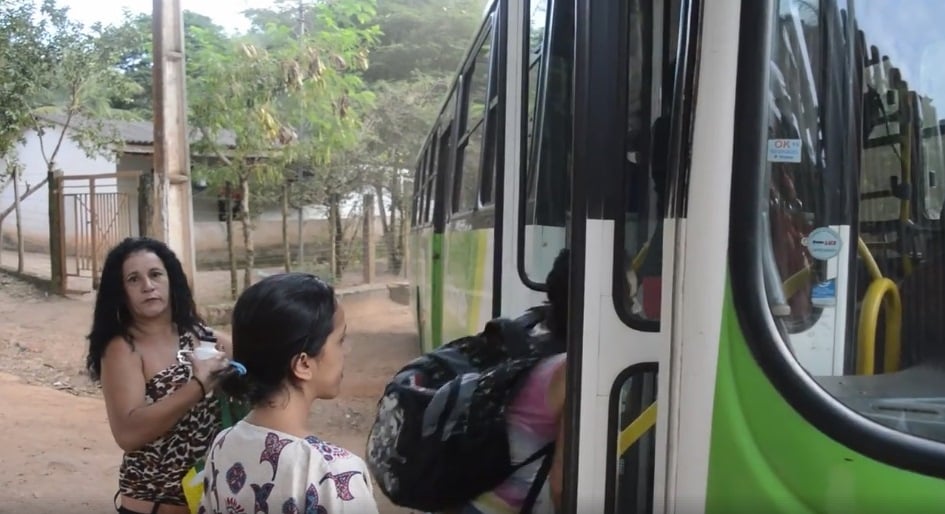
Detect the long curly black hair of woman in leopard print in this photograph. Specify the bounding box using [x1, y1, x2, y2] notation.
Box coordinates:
[85, 237, 203, 381]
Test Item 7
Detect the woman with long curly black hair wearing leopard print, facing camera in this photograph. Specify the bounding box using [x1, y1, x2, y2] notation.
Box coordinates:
[87, 238, 229, 514]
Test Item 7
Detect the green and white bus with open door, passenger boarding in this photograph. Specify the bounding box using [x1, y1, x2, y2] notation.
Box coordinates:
[408, 0, 945, 508]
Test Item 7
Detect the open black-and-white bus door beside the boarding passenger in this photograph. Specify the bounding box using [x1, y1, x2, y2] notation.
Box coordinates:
[563, 0, 698, 513]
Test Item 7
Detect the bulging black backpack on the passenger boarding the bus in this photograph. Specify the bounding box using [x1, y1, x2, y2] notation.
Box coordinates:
[367, 307, 564, 512]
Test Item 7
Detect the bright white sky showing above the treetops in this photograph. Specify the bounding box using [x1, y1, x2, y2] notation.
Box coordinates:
[52, 0, 274, 31]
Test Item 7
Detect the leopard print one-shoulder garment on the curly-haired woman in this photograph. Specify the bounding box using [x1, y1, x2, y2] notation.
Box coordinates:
[118, 328, 222, 505]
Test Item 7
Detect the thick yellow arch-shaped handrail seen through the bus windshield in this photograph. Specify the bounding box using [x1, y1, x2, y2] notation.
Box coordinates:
[856, 278, 902, 375]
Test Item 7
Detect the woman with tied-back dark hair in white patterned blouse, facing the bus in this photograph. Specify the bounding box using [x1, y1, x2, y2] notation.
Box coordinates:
[200, 273, 377, 514]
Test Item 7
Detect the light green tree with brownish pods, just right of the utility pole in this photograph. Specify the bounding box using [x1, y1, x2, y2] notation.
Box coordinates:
[190, 0, 376, 287]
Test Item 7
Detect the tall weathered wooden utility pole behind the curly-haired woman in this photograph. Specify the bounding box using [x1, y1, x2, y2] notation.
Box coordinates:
[151, 0, 197, 287]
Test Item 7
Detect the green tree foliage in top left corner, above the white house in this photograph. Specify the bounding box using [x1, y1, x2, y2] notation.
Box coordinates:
[0, 0, 140, 168]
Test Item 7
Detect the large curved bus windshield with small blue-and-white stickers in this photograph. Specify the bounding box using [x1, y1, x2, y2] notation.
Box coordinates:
[731, 0, 945, 442]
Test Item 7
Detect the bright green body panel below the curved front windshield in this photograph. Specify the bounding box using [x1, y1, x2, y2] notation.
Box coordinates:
[705, 291, 945, 514]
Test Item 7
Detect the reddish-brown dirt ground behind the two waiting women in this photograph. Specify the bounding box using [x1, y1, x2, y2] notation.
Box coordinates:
[0, 274, 418, 514]
